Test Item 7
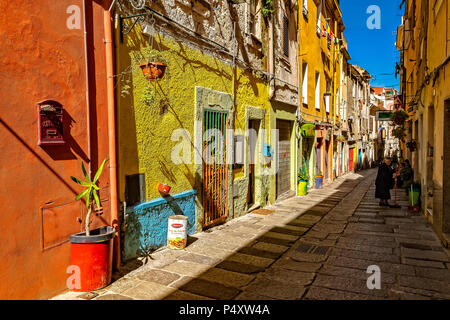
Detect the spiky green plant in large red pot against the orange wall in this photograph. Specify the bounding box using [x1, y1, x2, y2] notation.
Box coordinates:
[69, 159, 116, 291]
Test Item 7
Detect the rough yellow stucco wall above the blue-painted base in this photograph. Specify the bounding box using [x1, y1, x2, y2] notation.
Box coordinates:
[116, 26, 270, 201]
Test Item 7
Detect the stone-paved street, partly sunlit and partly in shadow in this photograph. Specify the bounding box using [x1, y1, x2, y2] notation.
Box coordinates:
[53, 170, 450, 300]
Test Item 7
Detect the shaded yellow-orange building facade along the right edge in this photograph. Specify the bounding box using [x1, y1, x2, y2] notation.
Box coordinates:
[397, 0, 450, 244]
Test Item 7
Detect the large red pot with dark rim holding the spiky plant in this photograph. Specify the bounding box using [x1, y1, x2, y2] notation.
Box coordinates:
[69, 226, 116, 291]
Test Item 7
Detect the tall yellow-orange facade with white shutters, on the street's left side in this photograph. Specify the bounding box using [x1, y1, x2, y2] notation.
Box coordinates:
[299, 0, 344, 180]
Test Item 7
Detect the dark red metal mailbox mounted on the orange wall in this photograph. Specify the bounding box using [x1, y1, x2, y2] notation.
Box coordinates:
[38, 100, 65, 146]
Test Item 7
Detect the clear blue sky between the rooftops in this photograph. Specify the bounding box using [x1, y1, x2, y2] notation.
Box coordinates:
[340, 0, 403, 90]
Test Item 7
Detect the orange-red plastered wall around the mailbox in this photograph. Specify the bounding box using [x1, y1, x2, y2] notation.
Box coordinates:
[0, 0, 109, 299]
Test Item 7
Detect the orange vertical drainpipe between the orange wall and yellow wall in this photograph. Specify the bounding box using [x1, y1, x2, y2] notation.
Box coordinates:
[103, 6, 120, 269]
